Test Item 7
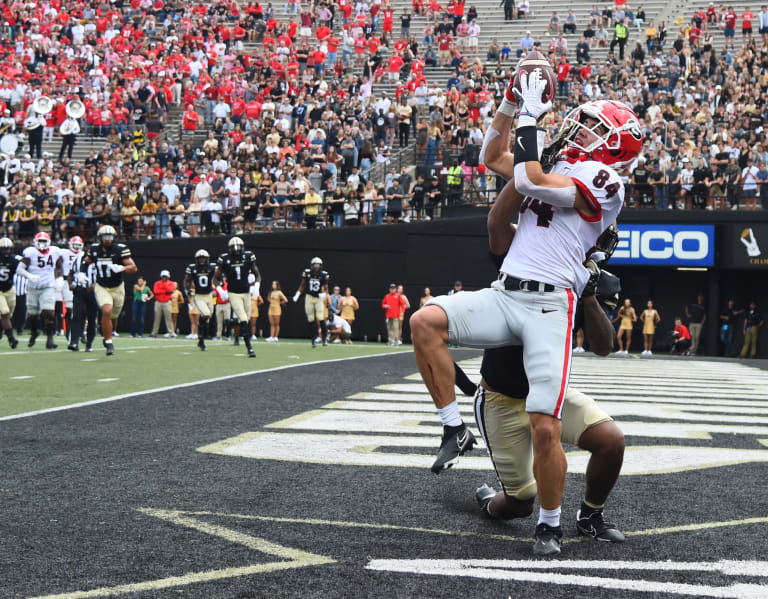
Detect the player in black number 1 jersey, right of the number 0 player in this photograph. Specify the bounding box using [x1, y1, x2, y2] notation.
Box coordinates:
[213, 237, 261, 358]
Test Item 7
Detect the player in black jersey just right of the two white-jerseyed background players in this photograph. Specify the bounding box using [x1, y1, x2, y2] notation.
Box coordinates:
[85, 225, 137, 356]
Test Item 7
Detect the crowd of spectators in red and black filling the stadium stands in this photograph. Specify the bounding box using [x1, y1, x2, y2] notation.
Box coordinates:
[0, 0, 768, 248]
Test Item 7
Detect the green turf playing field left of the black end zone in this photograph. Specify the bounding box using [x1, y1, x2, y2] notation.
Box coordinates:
[0, 336, 410, 417]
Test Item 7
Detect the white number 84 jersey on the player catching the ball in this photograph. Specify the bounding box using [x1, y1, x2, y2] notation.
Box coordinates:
[501, 160, 624, 295]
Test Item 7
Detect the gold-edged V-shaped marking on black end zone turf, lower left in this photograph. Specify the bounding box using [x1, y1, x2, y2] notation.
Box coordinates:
[32, 508, 336, 599]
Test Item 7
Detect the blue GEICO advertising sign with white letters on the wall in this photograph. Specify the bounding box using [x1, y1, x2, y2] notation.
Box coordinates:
[611, 224, 715, 266]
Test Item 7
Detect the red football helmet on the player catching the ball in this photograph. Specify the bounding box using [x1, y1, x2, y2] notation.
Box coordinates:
[561, 100, 643, 168]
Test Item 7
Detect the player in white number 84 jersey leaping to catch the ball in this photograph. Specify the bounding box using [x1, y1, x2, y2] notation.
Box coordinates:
[411, 71, 643, 555]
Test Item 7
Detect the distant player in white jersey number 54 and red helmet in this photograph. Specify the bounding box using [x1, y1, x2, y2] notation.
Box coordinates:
[16, 233, 61, 349]
